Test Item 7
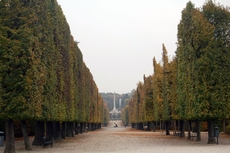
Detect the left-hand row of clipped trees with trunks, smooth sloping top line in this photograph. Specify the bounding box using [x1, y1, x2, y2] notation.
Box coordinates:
[0, 0, 109, 153]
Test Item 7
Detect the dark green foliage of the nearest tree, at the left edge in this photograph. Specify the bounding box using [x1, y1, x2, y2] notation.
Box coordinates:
[0, 1, 32, 119]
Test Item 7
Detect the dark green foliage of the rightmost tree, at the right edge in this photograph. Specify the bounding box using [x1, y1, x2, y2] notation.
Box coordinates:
[202, 1, 230, 118]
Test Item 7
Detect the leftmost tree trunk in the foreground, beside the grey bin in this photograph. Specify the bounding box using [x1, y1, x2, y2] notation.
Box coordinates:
[4, 119, 15, 153]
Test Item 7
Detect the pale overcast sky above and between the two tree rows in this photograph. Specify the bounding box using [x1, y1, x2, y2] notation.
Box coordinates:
[57, 0, 230, 94]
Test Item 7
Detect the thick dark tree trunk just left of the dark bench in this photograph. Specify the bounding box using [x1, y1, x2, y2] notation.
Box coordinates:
[32, 121, 44, 146]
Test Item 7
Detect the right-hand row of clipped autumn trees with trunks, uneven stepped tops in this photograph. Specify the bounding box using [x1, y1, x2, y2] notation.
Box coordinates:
[122, 0, 230, 143]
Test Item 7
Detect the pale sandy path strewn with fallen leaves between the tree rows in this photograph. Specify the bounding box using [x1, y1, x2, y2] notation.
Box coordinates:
[0, 121, 230, 153]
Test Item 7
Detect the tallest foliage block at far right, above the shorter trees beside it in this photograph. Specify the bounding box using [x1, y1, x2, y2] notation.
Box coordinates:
[176, 1, 230, 119]
